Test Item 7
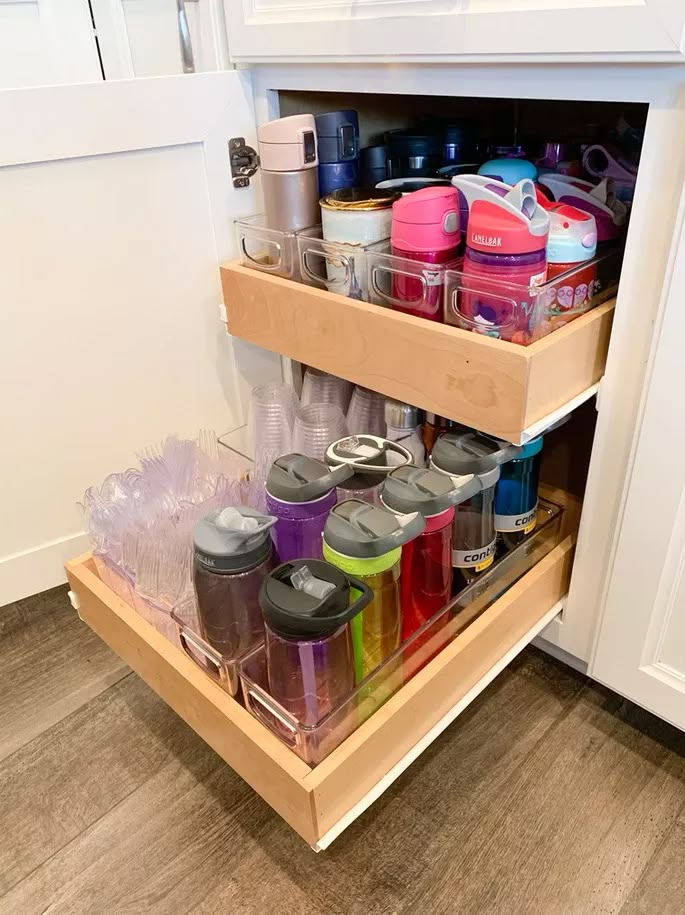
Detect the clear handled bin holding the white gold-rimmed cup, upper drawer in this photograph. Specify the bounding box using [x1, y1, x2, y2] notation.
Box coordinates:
[297, 226, 385, 302]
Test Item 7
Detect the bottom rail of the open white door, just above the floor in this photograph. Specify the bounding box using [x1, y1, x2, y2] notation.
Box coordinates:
[0, 534, 89, 607]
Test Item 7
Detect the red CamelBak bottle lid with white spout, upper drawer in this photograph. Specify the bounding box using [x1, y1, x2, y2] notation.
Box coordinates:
[452, 175, 549, 255]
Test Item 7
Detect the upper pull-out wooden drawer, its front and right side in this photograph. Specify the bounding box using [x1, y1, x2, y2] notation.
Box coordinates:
[221, 263, 614, 443]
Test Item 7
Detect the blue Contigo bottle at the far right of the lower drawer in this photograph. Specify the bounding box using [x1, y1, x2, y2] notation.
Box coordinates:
[495, 435, 542, 549]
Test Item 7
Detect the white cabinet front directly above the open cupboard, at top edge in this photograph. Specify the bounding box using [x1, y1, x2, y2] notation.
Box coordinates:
[224, 0, 685, 63]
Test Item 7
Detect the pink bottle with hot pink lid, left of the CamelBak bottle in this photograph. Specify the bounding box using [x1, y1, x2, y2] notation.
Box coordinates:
[390, 187, 461, 321]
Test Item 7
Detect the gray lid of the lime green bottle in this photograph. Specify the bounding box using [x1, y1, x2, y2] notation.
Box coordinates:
[323, 499, 426, 559]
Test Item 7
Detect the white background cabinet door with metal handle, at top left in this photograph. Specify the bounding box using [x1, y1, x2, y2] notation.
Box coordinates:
[90, 0, 228, 79]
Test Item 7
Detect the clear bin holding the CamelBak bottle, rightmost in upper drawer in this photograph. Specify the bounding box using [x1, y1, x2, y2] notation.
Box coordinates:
[444, 248, 623, 346]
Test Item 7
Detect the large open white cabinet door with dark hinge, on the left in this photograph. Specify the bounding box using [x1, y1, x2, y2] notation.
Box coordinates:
[0, 71, 280, 606]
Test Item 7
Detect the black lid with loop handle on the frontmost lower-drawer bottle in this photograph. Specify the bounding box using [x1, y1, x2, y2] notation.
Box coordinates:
[259, 559, 373, 640]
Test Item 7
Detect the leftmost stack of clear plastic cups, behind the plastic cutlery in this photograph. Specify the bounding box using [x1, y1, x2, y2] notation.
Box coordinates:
[249, 382, 297, 479]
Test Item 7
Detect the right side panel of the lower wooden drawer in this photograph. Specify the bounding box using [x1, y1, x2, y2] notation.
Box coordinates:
[307, 537, 574, 835]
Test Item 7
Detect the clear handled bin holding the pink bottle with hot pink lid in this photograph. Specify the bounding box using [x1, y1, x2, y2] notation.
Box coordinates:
[367, 242, 462, 321]
